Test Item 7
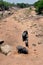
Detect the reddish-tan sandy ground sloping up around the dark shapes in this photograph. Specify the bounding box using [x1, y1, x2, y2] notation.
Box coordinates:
[0, 9, 43, 65]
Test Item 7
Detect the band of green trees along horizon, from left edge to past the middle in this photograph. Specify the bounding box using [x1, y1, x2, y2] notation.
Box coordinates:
[0, 0, 30, 10]
